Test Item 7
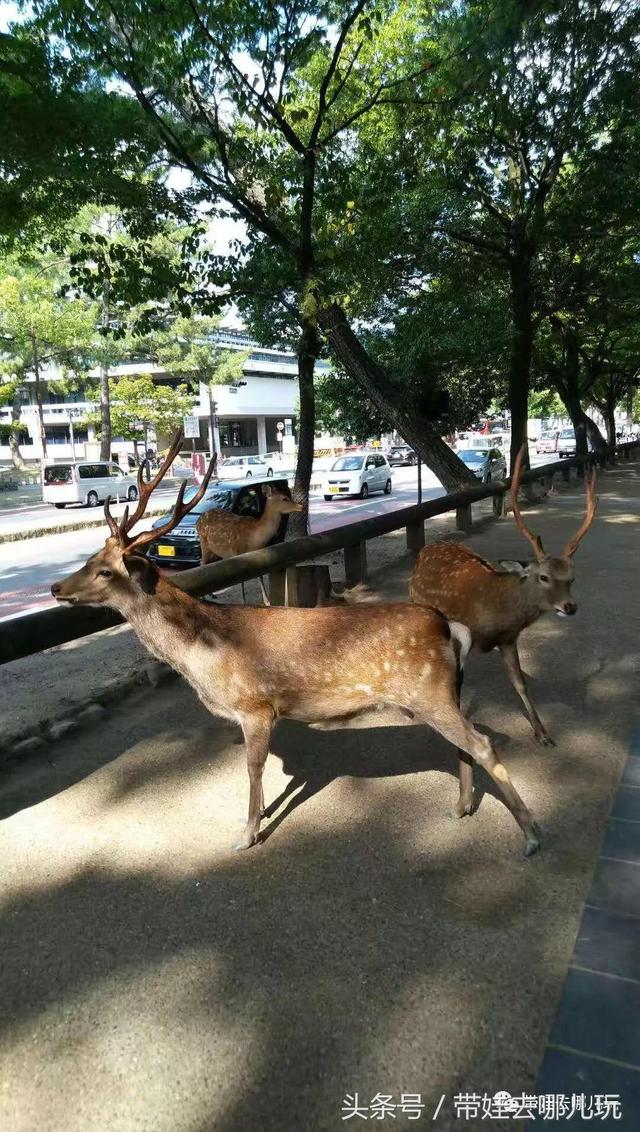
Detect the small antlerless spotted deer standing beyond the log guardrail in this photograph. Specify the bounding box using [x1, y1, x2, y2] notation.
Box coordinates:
[196, 483, 302, 606]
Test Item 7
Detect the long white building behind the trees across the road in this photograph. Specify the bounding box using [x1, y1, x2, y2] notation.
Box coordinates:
[0, 328, 327, 470]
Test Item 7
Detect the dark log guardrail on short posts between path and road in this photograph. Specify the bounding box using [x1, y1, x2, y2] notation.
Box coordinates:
[0, 441, 640, 664]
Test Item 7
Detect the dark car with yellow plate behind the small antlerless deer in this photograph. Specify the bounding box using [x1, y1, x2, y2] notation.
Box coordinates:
[147, 478, 291, 569]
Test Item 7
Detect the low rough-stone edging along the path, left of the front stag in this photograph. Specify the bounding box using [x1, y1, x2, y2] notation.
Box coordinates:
[0, 660, 178, 767]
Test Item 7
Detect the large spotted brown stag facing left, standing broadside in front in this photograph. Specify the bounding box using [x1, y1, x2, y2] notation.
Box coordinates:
[51, 438, 539, 857]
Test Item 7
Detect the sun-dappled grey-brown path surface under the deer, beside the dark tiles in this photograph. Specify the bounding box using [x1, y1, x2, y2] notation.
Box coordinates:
[0, 464, 640, 1132]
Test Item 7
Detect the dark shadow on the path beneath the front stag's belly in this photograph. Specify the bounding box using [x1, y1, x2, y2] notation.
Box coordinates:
[259, 712, 509, 842]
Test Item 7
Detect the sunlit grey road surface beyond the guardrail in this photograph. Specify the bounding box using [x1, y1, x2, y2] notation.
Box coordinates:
[0, 456, 546, 620]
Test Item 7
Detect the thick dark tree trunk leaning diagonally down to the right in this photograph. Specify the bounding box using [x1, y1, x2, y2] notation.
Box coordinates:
[318, 303, 478, 491]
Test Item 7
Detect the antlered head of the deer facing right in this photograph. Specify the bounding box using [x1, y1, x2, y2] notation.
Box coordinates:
[500, 445, 597, 617]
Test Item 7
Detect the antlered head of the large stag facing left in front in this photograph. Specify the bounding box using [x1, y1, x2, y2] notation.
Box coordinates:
[51, 430, 214, 612]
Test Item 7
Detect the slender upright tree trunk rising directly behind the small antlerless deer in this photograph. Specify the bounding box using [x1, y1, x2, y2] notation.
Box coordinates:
[287, 280, 319, 539]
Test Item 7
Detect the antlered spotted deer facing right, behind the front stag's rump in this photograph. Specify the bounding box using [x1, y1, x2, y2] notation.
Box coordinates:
[410, 447, 597, 816]
